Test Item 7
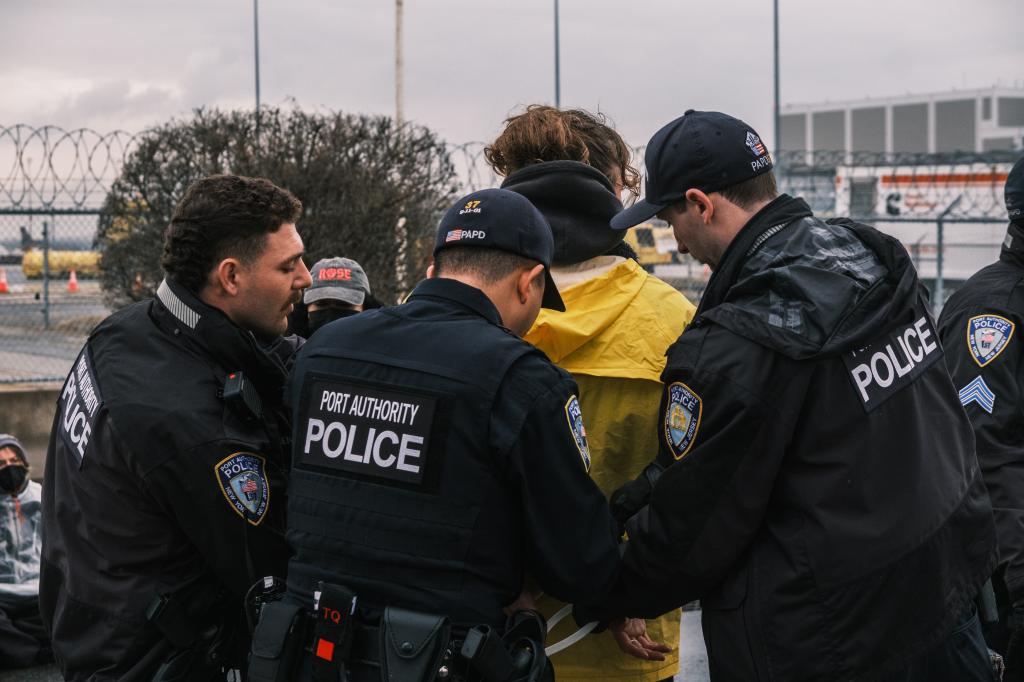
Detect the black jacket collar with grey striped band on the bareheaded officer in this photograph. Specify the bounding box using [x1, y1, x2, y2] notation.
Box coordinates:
[153, 280, 296, 394]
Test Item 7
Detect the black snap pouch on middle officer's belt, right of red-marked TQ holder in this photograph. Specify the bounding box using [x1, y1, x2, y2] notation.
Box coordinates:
[381, 606, 451, 682]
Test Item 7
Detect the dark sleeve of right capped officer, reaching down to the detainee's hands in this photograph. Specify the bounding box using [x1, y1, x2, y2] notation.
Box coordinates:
[578, 352, 808, 620]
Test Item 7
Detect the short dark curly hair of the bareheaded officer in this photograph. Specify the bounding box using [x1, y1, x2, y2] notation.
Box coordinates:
[160, 175, 302, 294]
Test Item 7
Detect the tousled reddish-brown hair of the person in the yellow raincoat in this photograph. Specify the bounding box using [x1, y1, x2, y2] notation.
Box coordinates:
[483, 104, 640, 197]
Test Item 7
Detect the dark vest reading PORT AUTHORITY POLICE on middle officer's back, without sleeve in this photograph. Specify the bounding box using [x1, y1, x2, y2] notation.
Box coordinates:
[280, 281, 547, 625]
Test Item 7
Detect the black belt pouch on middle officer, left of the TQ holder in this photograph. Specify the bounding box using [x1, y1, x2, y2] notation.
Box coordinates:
[249, 601, 304, 682]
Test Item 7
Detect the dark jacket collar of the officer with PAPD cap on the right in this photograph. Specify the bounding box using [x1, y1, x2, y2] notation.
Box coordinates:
[695, 195, 813, 316]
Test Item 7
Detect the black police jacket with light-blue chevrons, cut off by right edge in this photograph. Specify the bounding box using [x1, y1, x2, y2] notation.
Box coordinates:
[939, 224, 1024, 602]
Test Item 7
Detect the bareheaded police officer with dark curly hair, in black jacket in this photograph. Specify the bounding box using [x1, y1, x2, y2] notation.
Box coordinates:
[40, 175, 310, 681]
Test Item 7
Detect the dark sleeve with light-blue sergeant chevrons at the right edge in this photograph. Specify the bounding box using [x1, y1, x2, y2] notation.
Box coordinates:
[939, 306, 1024, 601]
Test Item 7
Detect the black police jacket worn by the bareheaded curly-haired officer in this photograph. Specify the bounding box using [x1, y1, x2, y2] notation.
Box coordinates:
[40, 282, 295, 681]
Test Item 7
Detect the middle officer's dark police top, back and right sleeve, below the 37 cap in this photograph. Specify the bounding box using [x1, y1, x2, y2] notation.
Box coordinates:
[288, 279, 618, 626]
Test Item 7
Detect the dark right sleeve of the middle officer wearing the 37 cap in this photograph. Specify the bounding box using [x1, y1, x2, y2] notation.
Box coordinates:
[493, 368, 620, 602]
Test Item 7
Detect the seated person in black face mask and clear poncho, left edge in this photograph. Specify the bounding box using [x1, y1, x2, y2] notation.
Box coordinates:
[0, 433, 52, 669]
